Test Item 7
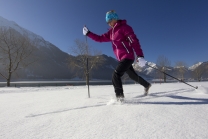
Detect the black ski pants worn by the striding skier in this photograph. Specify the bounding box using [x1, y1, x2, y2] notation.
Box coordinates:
[112, 59, 150, 97]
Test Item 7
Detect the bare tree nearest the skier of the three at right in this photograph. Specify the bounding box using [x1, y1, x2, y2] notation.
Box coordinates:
[156, 55, 171, 82]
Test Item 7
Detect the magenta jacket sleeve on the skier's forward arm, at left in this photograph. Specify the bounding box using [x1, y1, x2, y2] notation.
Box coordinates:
[87, 31, 111, 42]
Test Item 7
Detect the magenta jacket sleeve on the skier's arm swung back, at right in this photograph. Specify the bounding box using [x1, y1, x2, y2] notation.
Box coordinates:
[122, 25, 144, 57]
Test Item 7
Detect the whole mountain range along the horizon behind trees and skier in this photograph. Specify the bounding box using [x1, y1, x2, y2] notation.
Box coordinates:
[0, 16, 208, 80]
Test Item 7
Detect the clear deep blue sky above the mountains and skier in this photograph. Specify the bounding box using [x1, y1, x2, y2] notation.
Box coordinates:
[0, 0, 208, 66]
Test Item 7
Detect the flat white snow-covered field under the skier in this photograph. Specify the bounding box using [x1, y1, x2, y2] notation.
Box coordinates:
[0, 82, 208, 139]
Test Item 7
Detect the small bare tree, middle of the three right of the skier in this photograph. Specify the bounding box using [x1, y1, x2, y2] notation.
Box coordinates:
[176, 61, 187, 81]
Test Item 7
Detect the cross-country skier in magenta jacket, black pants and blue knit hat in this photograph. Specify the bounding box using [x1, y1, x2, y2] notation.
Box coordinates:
[83, 10, 151, 100]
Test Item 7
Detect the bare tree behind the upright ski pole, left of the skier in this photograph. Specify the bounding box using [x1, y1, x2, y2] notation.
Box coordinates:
[68, 39, 104, 83]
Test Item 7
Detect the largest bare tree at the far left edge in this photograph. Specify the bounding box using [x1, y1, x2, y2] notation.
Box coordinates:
[0, 28, 35, 86]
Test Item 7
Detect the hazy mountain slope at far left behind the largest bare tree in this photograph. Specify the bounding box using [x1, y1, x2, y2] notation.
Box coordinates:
[0, 16, 73, 79]
